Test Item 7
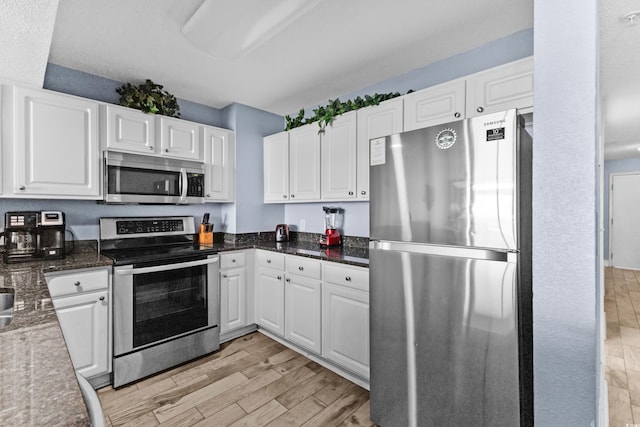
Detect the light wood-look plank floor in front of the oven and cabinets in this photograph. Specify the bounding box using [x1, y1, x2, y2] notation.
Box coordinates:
[98, 332, 373, 427]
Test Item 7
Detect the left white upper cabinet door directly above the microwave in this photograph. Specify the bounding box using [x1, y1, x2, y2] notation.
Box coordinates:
[101, 105, 159, 154]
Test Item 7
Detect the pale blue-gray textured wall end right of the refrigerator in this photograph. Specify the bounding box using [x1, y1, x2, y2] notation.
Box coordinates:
[533, 0, 602, 426]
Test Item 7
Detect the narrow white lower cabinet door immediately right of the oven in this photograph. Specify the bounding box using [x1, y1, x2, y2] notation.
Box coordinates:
[220, 268, 247, 333]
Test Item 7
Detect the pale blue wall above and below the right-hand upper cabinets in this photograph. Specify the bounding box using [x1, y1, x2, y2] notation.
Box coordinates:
[284, 29, 533, 237]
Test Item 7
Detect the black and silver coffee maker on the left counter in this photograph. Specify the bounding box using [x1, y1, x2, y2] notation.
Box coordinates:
[3, 211, 65, 263]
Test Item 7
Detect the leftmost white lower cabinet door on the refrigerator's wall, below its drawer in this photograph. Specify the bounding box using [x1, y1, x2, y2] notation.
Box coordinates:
[256, 268, 284, 336]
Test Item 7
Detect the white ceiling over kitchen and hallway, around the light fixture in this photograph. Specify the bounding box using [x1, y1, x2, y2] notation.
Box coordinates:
[49, 0, 640, 158]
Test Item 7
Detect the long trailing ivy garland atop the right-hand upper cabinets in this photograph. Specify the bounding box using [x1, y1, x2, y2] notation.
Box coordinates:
[284, 90, 413, 132]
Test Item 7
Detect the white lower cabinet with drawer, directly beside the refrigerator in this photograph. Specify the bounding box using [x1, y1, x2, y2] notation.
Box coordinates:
[322, 263, 369, 379]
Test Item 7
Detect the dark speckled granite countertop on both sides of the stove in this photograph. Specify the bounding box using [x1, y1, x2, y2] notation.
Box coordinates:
[0, 233, 369, 426]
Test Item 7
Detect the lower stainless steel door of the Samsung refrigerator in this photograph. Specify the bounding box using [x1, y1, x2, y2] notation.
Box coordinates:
[369, 249, 520, 427]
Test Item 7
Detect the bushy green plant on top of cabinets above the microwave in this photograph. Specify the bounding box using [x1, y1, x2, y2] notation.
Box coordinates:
[116, 79, 180, 117]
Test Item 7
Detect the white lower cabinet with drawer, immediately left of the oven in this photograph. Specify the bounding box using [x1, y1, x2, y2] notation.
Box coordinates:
[46, 268, 111, 378]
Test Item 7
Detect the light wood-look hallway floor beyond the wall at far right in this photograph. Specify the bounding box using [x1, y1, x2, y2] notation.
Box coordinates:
[604, 268, 640, 427]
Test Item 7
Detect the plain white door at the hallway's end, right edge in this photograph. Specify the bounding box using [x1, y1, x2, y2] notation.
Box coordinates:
[609, 173, 640, 269]
